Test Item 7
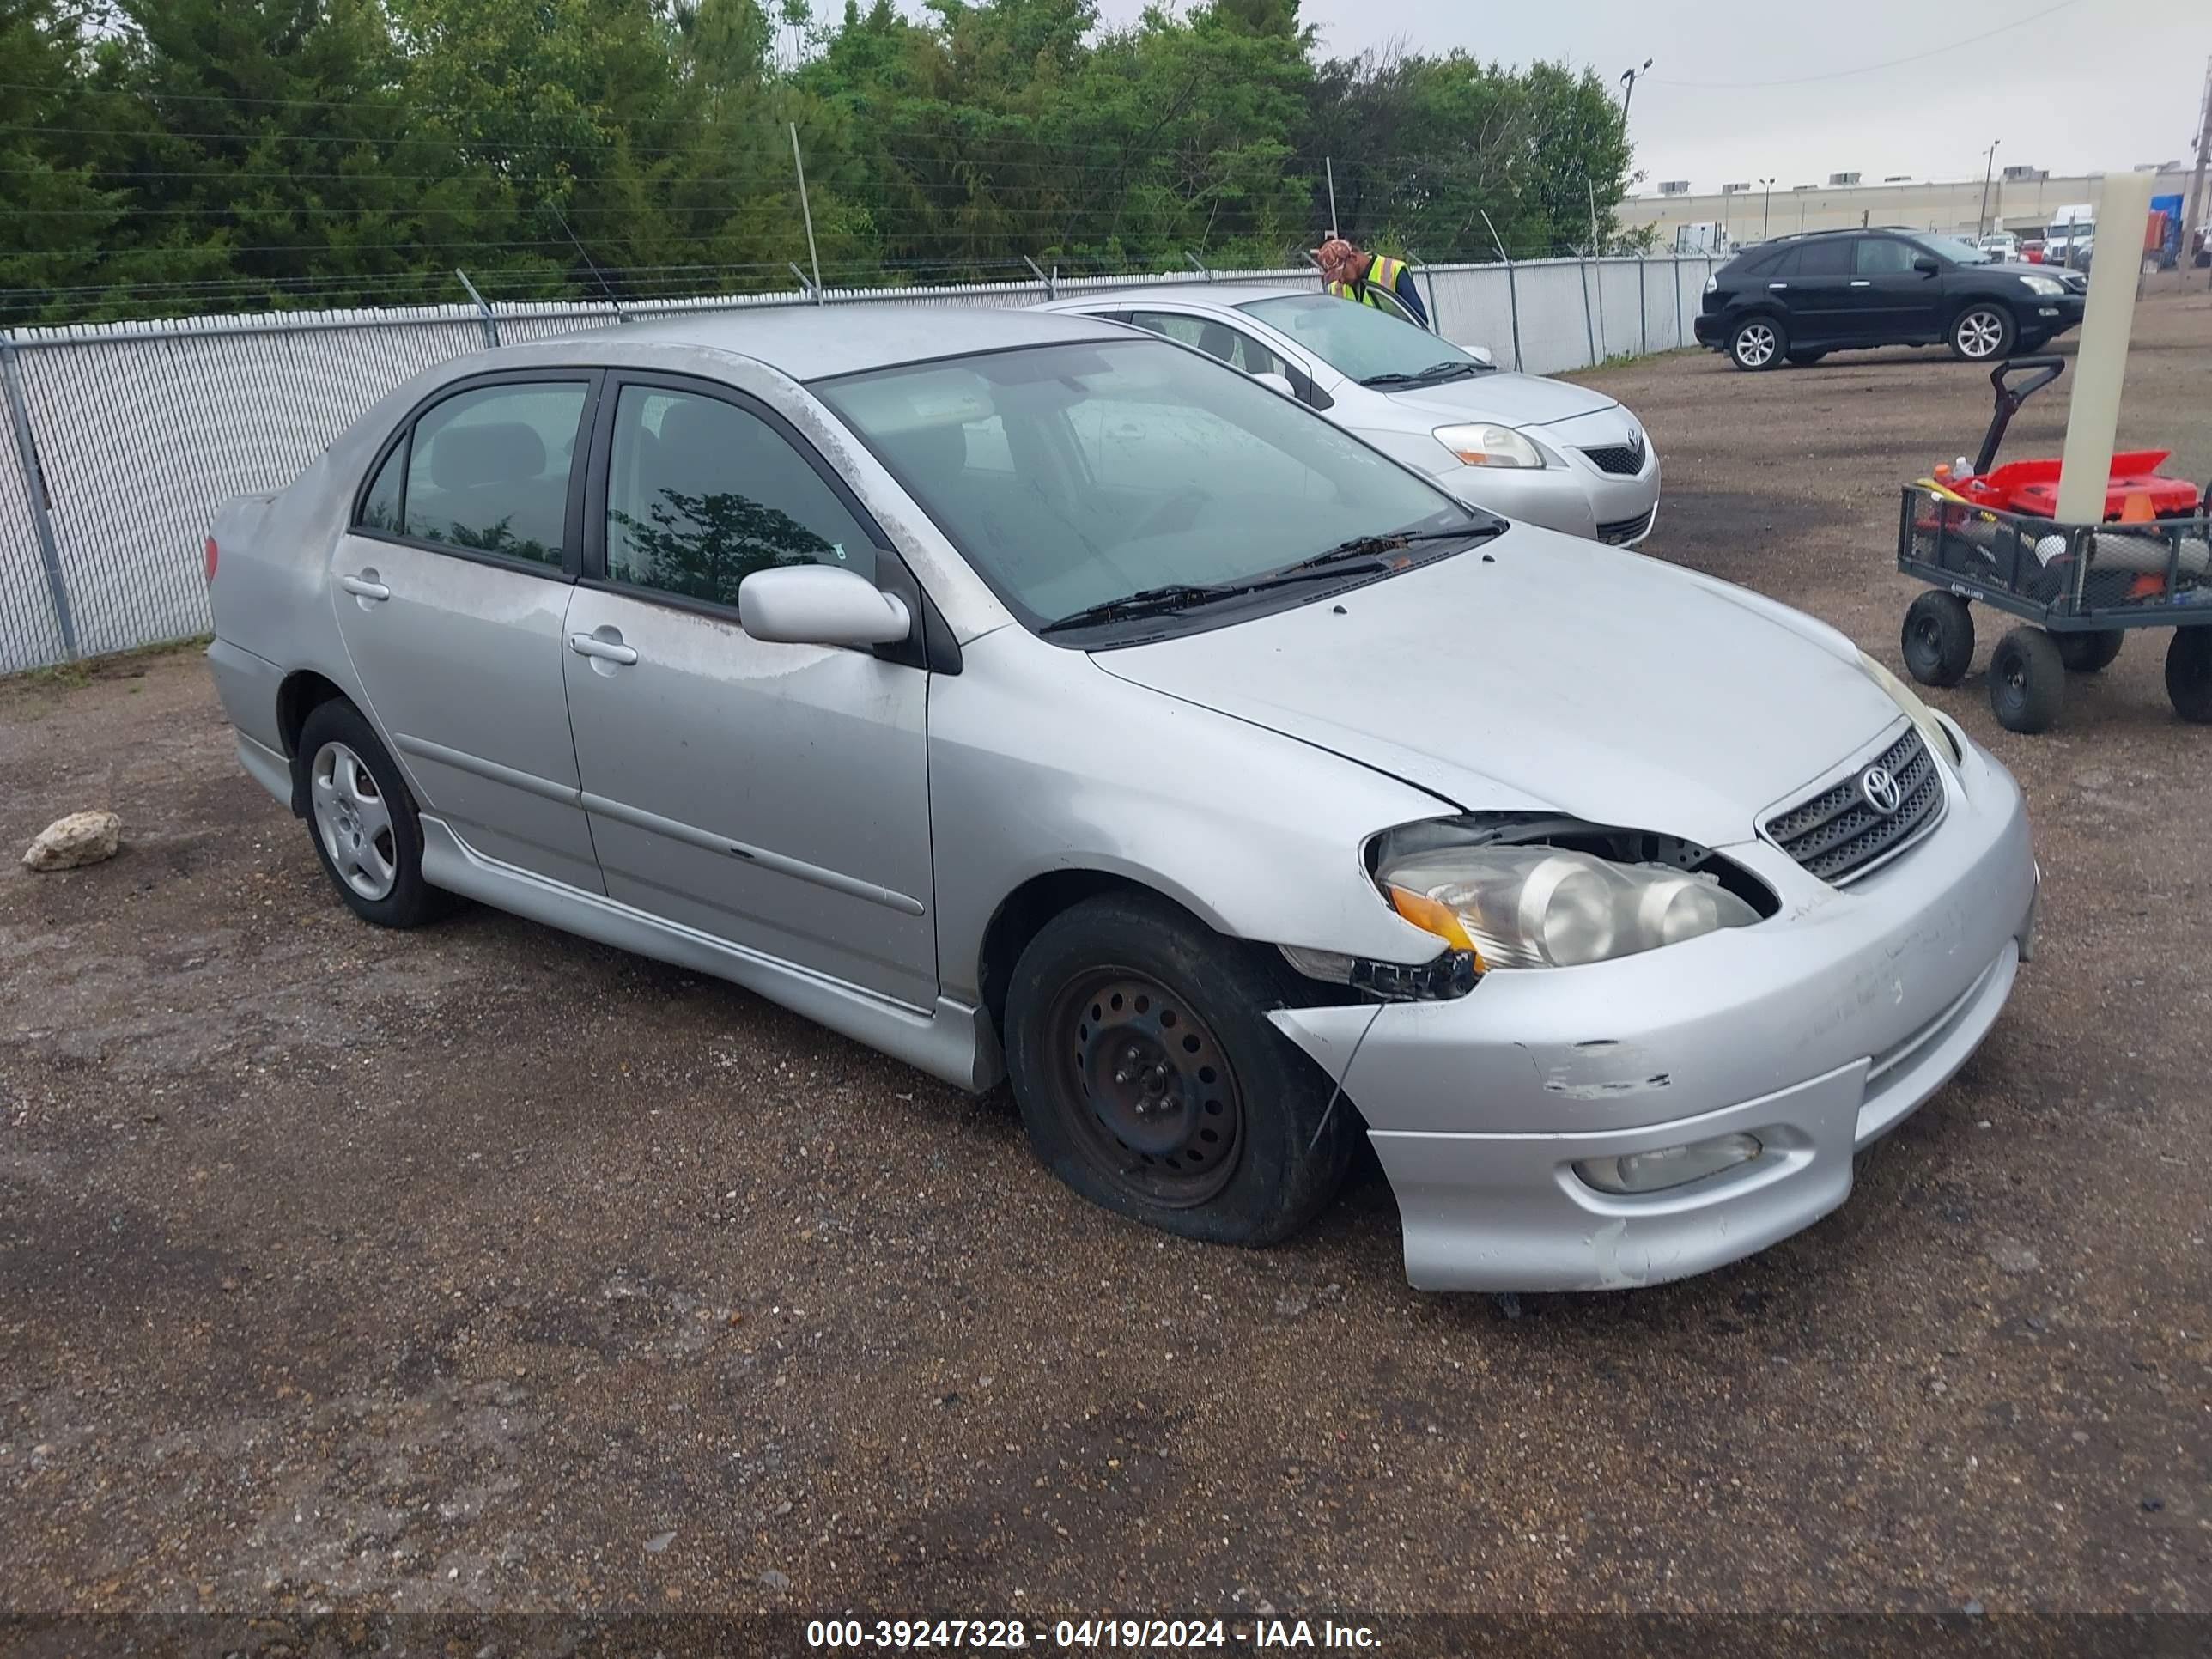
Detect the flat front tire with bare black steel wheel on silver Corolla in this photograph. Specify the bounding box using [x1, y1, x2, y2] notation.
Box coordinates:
[1006, 894, 1358, 1245]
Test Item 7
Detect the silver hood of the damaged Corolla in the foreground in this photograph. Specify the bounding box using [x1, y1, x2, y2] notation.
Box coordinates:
[1093, 525, 1900, 848]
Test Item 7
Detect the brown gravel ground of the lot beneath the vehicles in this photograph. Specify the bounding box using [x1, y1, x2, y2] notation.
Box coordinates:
[13, 296, 2212, 1617]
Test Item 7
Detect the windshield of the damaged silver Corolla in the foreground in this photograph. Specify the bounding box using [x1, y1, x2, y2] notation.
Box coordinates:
[811, 338, 1495, 633]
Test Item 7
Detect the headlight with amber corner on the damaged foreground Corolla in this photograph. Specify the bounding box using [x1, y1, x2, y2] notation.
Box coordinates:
[1376, 842, 1759, 969]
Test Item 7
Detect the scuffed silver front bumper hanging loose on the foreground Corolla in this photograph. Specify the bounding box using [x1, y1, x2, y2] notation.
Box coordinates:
[1272, 748, 2039, 1290]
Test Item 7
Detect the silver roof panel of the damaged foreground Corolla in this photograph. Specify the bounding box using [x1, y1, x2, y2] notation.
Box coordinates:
[577, 301, 1124, 380]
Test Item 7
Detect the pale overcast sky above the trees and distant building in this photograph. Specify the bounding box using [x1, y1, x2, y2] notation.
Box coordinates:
[1102, 0, 2212, 191]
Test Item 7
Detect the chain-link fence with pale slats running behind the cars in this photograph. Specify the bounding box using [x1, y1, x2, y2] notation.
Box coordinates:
[0, 257, 1714, 675]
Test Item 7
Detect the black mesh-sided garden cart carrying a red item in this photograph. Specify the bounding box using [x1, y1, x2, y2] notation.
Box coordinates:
[1898, 358, 2212, 732]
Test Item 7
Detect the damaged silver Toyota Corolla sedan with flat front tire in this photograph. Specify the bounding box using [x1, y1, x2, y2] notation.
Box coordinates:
[208, 307, 2037, 1290]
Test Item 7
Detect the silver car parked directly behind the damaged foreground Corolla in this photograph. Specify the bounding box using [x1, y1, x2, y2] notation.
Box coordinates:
[1040, 283, 1659, 546]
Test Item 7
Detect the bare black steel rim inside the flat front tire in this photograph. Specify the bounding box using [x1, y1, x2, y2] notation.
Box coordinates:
[1046, 967, 1245, 1210]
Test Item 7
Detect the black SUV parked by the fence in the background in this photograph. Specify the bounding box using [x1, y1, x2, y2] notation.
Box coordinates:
[1697, 230, 2088, 369]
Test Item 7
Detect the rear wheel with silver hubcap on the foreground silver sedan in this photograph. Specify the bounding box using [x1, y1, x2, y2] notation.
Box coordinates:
[292, 699, 453, 927]
